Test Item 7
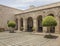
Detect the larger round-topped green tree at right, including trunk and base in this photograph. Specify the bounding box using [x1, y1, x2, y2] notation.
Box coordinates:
[42, 16, 57, 38]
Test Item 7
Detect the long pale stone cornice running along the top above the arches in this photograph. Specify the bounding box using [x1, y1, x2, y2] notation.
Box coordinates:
[16, 2, 60, 15]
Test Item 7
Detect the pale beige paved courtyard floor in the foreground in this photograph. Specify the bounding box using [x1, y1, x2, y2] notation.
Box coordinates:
[0, 32, 60, 46]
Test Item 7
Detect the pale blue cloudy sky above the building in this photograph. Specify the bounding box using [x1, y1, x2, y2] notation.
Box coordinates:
[0, 0, 60, 10]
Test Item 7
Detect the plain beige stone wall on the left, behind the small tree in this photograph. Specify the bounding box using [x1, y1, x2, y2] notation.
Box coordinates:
[0, 5, 22, 29]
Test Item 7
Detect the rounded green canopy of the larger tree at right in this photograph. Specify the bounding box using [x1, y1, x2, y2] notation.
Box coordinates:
[42, 16, 57, 26]
